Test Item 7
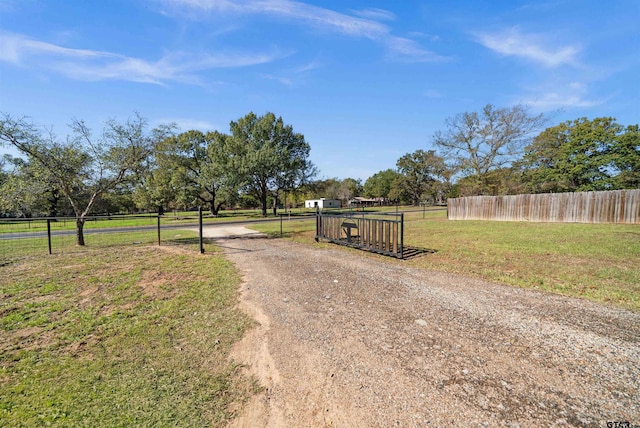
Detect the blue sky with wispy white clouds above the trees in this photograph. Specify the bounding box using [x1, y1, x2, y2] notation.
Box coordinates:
[0, 0, 640, 181]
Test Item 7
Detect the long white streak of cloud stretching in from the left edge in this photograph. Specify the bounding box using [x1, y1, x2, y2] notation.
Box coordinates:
[0, 33, 282, 84]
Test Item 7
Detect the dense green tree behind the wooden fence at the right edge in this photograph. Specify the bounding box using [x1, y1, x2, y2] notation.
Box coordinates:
[519, 117, 640, 193]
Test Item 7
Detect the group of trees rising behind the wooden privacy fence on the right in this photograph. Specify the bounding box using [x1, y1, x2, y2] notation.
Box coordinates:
[363, 105, 640, 204]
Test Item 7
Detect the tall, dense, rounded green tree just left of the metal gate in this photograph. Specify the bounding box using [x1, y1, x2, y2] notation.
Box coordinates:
[229, 113, 316, 216]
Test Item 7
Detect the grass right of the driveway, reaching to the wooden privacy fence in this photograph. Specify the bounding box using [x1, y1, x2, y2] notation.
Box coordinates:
[253, 211, 640, 311]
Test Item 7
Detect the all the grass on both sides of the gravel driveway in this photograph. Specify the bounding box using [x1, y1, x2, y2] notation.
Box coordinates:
[0, 206, 640, 427]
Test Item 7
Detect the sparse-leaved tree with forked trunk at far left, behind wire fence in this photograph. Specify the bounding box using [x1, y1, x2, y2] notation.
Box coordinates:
[0, 114, 157, 245]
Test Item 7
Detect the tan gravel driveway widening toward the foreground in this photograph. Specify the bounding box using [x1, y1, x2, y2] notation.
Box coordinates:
[212, 234, 640, 427]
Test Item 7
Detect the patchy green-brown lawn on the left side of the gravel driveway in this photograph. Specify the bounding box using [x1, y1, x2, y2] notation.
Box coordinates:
[0, 247, 257, 427]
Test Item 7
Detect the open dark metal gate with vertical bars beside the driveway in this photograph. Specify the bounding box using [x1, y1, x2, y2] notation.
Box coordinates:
[316, 212, 404, 259]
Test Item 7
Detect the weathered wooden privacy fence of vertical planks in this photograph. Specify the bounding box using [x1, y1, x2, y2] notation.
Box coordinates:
[447, 189, 640, 224]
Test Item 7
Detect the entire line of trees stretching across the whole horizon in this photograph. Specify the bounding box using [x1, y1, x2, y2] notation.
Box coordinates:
[0, 105, 640, 245]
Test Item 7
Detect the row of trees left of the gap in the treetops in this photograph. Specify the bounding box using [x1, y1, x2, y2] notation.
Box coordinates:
[0, 113, 316, 245]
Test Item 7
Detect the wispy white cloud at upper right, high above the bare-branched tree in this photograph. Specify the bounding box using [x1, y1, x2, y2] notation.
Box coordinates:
[476, 27, 580, 67]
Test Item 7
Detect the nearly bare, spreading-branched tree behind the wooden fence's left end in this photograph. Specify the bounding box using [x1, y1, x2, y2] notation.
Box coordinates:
[434, 104, 547, 194]
